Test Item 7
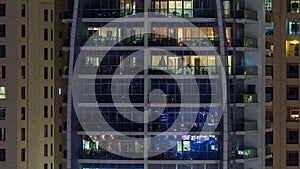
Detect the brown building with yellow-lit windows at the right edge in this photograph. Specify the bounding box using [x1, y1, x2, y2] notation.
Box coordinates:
[265, 0, 300, 169]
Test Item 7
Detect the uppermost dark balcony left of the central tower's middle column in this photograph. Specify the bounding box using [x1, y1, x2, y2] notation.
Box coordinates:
[79, 8, 144, 18]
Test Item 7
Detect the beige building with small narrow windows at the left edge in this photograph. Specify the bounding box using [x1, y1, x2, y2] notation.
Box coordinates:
[0, 0, 67, 169]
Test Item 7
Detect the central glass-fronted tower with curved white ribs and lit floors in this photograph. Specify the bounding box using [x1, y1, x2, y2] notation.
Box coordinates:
[63, 0, 265, 169]
